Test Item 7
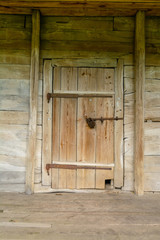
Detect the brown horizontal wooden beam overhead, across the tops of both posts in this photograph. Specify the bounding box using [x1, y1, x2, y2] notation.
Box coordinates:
[0, 0, 160, 16]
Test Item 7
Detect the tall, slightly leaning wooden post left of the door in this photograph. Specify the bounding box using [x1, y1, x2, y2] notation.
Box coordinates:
[26, 10, 40, 194]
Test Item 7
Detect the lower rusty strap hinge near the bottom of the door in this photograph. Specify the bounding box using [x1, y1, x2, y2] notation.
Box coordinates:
[46, 163, 113, 175]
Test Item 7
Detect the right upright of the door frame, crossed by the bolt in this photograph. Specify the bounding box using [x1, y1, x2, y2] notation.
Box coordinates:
[114, 59, 123, 188]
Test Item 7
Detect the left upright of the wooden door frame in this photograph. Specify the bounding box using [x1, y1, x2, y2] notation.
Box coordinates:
[42, 60, 52, 186]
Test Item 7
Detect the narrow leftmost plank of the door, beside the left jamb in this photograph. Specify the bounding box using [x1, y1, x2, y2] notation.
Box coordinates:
[52, 67, 61, 189]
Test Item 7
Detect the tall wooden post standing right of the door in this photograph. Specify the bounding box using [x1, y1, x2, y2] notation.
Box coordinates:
[135, 11, 145, 195]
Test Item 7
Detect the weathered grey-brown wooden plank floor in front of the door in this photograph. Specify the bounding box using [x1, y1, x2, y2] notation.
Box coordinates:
[0, 192, 160, 240]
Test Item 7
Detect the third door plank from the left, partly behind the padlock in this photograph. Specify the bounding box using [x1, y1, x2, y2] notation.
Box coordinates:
[77, 68, 97, 189]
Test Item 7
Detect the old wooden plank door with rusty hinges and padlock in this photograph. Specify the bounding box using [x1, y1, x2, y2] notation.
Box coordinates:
[52, 67, 114, 189]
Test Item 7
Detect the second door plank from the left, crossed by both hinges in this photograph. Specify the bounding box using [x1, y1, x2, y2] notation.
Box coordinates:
[59, 67, 77, 189]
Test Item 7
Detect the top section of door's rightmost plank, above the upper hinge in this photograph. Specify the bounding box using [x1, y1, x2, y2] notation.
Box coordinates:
[96, 68, 114, 92]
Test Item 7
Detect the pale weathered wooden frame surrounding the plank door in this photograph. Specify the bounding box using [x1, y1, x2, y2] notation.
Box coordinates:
[35, 59, 124, 192]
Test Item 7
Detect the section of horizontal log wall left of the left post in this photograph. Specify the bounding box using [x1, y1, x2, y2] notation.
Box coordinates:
[0, 15, 31, 192]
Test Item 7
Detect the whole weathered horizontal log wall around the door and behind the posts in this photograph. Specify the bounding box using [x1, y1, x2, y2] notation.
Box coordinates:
[0, 15, 160, 191]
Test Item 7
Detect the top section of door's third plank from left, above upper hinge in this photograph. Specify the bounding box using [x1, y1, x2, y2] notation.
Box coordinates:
[78, 68, 97, 91]
